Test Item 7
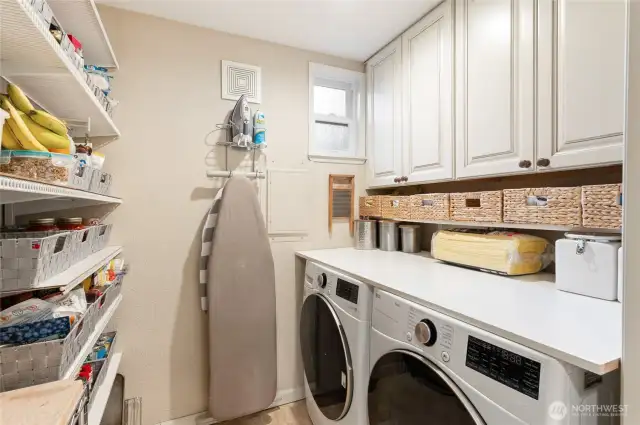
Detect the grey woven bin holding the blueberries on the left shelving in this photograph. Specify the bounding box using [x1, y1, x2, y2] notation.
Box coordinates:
[0, 281, 121, 392]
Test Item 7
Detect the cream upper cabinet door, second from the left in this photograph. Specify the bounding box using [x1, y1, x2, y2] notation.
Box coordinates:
[402, 0, 453, 183]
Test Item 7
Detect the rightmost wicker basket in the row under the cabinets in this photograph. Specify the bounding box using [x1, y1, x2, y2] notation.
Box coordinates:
[582, 184, 622, 229]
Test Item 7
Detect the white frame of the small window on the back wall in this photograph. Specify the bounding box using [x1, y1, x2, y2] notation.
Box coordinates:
[308, 62, 367, 164]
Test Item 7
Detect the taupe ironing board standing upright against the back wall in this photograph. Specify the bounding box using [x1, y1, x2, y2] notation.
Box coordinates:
[207, 177, 277, 421]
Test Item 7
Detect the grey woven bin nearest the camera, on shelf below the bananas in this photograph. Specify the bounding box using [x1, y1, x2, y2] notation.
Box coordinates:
[0, 232, 73, 291]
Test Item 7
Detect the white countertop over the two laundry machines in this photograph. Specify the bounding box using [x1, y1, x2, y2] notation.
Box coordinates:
[296, 248, 622, 374]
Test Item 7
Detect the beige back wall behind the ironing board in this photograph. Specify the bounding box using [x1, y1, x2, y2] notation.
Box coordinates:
[100, 7, 364, 425]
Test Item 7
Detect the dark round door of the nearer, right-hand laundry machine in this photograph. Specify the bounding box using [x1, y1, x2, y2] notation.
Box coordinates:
[368, 350, 485, 425]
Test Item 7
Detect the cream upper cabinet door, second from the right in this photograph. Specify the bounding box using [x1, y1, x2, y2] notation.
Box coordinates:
[456, 0, 544, 177]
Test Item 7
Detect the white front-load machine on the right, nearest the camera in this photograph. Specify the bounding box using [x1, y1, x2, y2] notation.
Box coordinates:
[368, 289, 624, 425]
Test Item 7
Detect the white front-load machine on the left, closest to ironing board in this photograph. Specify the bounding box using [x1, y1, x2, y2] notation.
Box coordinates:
[300, 261, 373, 425]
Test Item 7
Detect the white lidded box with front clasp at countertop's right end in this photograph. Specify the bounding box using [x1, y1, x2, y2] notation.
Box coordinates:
[556, 233, 621, 300]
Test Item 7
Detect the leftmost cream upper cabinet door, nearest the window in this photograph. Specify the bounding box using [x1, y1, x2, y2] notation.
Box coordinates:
[367, 39, 402, 187]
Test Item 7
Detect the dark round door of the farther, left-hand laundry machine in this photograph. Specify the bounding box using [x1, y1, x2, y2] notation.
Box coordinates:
[300, 294, 353, 421]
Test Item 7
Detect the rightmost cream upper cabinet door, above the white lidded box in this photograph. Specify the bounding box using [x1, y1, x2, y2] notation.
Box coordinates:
[537, 0, 626, 170]
